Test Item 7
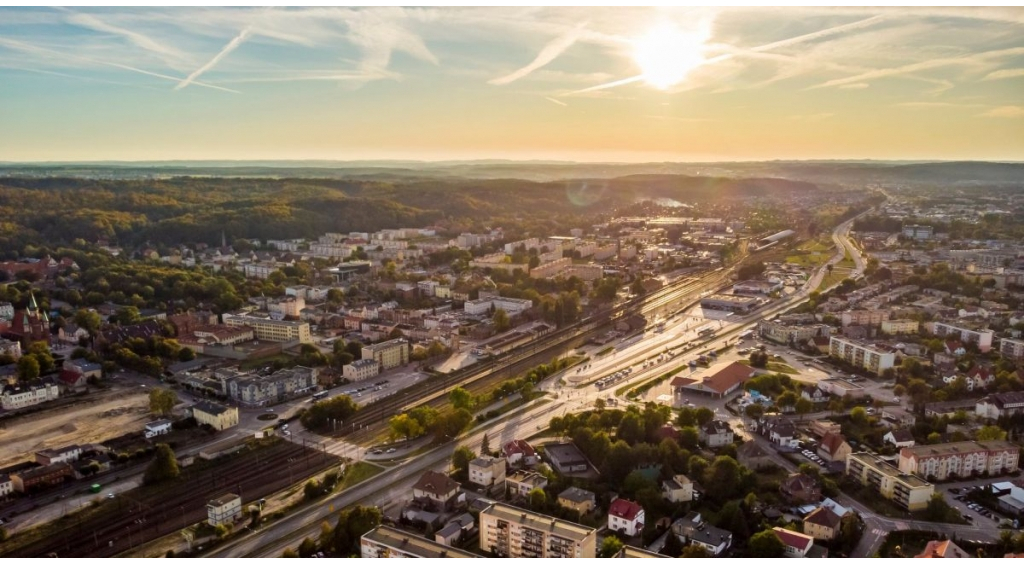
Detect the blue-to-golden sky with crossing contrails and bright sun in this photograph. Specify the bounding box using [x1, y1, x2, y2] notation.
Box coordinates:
[0, 7, 1024, 162]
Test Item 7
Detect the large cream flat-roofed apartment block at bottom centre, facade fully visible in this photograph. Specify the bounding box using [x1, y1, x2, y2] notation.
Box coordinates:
[480, 504, 597, 558]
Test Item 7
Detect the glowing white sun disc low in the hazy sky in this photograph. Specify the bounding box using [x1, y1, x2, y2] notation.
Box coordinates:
[633, 23, 707, 90]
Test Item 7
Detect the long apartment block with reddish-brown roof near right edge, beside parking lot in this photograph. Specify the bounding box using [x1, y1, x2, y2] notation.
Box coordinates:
[899, 440, 1020, 480]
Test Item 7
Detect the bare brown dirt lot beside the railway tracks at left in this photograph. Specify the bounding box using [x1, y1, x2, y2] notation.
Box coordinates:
[0, 390, 150, 467]
